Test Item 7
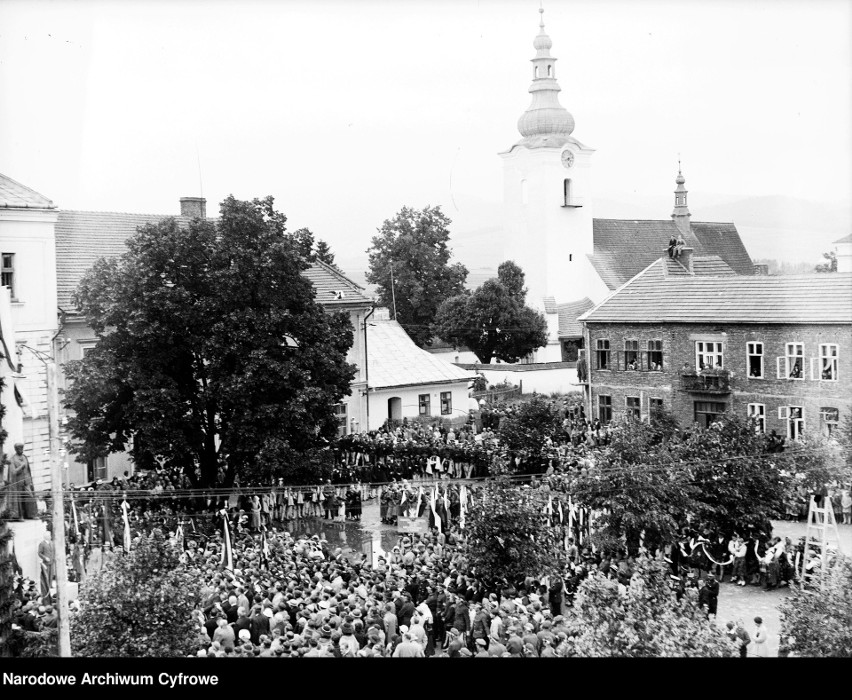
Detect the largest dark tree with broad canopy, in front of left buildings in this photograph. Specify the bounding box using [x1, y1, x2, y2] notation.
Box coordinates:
[66, 197, 354, 485]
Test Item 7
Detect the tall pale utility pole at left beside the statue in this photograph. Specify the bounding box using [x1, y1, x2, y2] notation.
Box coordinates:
[45, 358, 71, 657]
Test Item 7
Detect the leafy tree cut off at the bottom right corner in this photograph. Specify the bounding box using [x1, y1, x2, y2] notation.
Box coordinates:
[779, 557, 852, 658]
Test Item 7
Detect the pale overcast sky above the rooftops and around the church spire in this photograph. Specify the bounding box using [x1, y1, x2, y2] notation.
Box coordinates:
[0, 0, 852, 270]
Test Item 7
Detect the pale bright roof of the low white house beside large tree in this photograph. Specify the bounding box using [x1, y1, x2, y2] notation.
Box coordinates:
[367, 319, 476, 389]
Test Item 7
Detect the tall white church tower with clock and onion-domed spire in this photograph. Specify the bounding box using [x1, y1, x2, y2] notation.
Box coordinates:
[500, 9, 594, 310]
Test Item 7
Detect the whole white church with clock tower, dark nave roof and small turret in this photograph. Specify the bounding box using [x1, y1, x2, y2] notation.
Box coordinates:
[499, 9, 754, 363]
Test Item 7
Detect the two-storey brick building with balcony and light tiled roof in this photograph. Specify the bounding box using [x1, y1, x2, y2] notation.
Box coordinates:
[581, 250, 852, 439]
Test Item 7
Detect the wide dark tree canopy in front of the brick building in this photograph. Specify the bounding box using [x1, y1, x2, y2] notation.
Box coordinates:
[567, 414, 804, 550]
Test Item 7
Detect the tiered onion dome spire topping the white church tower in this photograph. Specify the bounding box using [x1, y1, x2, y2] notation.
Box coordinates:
[518, 8, 574, 148]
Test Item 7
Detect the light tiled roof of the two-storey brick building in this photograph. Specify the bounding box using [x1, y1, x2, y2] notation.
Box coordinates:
[581, 260, 852, 324]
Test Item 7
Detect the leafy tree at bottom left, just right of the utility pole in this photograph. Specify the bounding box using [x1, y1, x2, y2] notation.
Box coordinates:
[71, 530, 201, 657]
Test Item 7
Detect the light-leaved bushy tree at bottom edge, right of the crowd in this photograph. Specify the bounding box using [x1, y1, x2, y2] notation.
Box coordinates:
[567, 558, 738, 658]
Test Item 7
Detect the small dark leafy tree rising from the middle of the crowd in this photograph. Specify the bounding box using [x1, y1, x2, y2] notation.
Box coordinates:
[464, 478, 564, 582]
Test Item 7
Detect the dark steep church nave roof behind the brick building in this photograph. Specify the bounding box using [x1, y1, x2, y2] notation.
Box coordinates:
[589, 219, 754, 289]
